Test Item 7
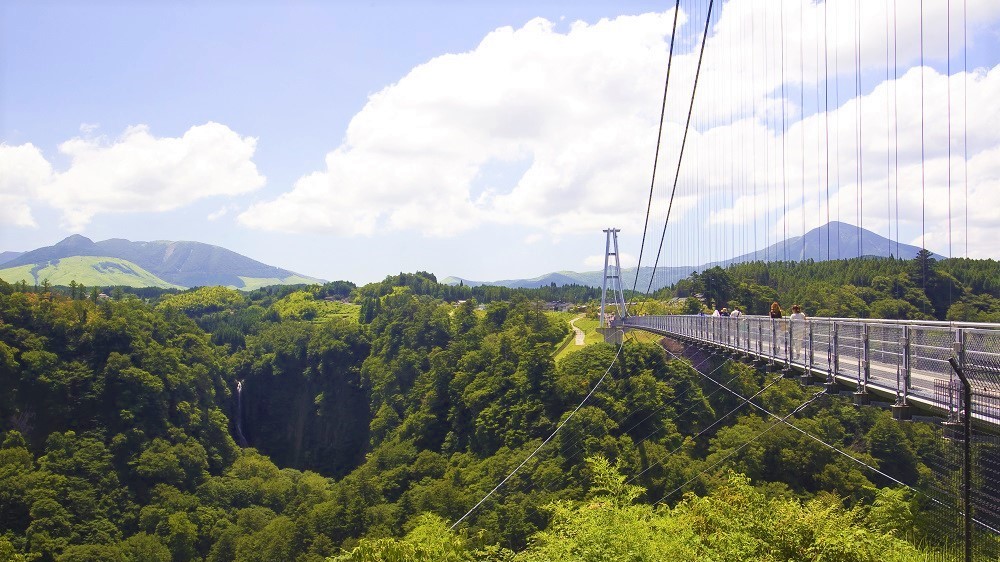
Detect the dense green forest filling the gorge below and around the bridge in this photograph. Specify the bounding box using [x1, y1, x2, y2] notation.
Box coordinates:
[0, 260, 1000, 561]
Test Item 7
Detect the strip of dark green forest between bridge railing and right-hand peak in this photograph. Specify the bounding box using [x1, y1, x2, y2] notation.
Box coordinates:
[657, 250, 1000, 322]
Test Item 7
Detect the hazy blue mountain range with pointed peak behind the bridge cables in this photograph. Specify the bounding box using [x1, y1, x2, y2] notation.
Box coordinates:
[441, 222, 943, 291]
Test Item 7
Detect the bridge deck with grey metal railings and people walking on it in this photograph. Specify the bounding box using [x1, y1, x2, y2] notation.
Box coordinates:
[615, 315, 1000, 429]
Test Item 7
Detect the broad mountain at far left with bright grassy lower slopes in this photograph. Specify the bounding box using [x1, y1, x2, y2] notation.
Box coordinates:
[0, 234, 322, 290]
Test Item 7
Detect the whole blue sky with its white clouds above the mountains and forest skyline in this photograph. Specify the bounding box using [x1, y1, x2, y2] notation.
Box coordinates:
[0, 0, 1000, 283]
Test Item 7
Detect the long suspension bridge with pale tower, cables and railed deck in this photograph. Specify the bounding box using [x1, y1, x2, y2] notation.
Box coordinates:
[455, 0, 1000, 560]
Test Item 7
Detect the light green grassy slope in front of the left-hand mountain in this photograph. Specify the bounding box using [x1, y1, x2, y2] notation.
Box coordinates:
[0, 256, 183, 289]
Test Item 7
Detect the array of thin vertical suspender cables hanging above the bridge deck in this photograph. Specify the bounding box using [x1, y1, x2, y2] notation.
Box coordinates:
[626, 0, 982, 284]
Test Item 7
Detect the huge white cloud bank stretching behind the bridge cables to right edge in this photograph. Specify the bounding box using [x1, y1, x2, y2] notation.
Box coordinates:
[239, 0, 1000, 265]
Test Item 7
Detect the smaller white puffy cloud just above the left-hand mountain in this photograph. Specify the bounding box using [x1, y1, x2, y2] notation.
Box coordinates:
[0, 122, 265, 230]
